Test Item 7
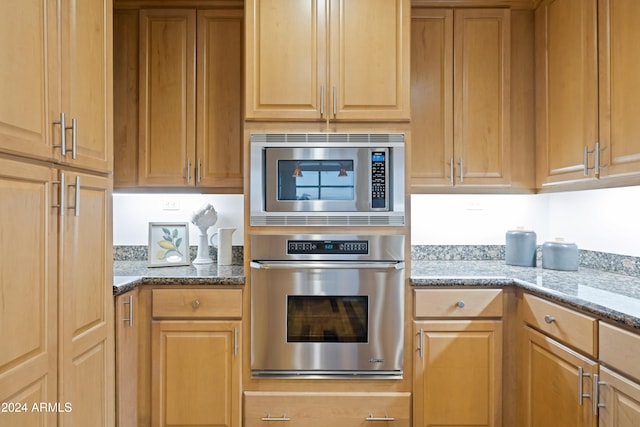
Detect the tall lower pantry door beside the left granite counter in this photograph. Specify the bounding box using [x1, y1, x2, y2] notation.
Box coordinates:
[58, 173, 115, 426]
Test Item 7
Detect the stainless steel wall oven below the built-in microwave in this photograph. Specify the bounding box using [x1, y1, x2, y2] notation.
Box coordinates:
[251, 235, 404, 378]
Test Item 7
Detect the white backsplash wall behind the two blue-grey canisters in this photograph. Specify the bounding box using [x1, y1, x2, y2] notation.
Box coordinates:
[411, 186, 640, 256]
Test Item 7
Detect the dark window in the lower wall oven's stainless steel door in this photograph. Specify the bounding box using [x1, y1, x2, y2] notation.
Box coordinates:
[287, 295, 369, 343]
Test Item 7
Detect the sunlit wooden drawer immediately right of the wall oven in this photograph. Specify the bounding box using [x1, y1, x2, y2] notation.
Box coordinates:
[414, 289, 503, 318]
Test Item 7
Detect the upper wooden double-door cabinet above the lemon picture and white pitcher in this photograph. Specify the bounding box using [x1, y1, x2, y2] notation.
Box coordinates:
[114, 9, 243, 192]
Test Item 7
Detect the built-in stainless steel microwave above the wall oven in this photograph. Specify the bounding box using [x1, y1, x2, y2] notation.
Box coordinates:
[250, 133, 405, 225]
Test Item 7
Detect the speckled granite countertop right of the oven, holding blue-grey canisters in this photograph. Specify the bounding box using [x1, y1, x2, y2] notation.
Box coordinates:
[410, 260, 640, 330]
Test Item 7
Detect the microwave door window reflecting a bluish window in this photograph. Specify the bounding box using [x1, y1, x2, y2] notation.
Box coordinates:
[278, 160, 355, 200]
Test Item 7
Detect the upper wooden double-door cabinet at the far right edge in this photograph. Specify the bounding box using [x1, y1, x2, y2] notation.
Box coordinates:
[536, 0, 640, 187]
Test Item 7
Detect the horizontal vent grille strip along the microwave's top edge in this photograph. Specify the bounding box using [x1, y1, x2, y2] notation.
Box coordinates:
[251, 132, 404, 144]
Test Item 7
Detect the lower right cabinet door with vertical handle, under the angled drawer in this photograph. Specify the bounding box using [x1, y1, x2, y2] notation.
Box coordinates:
[521, 327, 598, 427]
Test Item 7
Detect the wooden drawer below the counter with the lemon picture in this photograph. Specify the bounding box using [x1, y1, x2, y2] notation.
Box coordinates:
[152, 289, 242, 319]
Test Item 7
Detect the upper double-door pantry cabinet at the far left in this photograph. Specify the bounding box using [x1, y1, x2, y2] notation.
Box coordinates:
[0, 0, 113, 172]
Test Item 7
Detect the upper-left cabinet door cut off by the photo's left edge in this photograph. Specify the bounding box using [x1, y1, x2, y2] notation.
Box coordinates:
[0, 0, 60, 159]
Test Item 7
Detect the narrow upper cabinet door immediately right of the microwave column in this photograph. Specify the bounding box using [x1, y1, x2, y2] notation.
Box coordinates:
[408, 8, 454, 189]
